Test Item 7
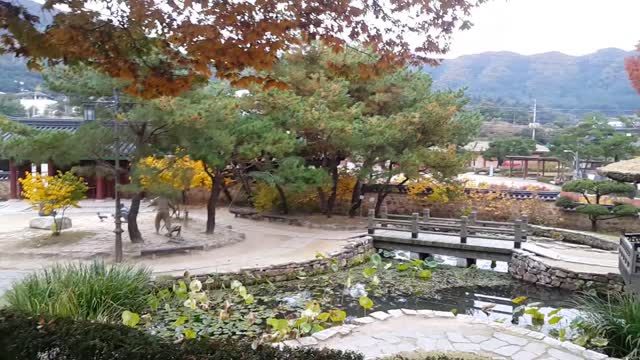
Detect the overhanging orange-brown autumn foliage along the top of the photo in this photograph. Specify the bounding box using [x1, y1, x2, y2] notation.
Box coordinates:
[0, 0, 486, 98]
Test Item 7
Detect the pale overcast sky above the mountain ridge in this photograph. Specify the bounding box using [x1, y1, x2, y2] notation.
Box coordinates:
[446, 0, 640, 57]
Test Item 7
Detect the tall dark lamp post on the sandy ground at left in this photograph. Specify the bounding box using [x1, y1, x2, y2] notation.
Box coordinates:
[83, 89, 124, 263]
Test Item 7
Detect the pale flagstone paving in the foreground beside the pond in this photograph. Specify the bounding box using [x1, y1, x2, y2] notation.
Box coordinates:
[296, 309, 607, 360]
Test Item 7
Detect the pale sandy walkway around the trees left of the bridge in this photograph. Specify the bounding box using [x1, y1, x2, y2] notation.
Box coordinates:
[0, 200, 364, 294]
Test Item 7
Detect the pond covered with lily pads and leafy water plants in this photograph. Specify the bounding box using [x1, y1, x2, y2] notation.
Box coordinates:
[146, 252, 577, 338]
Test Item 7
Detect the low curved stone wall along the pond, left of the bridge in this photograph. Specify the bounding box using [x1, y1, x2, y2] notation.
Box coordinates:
[196, 236, 375, 288]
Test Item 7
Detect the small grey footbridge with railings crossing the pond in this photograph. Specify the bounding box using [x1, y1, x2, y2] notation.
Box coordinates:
[368, 209, 528, 265]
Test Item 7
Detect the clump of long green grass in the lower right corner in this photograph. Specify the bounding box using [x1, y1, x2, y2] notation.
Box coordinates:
[576, 294, 640, 359]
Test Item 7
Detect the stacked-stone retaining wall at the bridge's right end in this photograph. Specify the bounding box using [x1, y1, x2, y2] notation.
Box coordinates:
[509, 250, 624, 292]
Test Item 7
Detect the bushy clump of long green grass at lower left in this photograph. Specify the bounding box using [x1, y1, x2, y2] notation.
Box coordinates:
[5, 261, 151, 321]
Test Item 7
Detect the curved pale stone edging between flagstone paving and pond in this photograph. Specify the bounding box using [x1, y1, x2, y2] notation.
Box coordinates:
[274, 309, 619, 360]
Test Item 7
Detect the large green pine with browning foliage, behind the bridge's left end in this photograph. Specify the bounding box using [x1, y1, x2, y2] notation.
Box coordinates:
[250, 45, 480, 215]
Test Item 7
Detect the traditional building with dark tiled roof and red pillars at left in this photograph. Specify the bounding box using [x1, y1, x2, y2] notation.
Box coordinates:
[0, 117, 131, 200]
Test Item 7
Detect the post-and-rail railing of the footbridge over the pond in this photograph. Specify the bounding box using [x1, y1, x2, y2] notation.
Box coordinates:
[368, 209, 528, 249]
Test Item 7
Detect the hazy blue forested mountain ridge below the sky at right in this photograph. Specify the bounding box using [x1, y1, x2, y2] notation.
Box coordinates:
[424, 48, 640, 113]
